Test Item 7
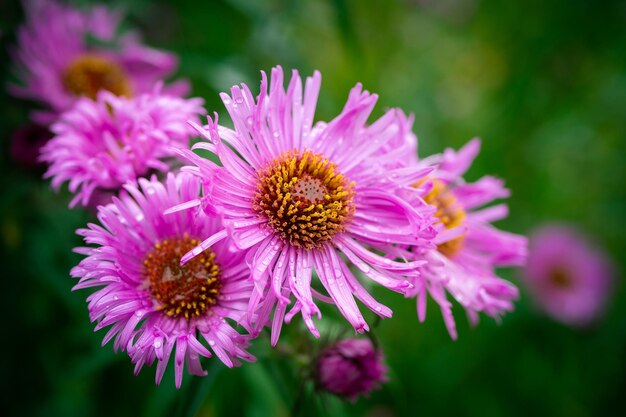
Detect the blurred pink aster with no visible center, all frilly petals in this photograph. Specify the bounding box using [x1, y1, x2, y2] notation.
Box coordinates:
[41, 86, 204, 207]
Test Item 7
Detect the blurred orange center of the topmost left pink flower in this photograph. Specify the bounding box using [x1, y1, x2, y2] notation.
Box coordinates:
[63, 55, 131, 100]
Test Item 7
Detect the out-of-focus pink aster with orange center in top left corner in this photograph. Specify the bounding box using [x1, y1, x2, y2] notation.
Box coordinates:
[11, 0, 188, 124]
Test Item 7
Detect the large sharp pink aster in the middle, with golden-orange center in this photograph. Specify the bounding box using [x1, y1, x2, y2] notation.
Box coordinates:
[174, 67, 434, 344]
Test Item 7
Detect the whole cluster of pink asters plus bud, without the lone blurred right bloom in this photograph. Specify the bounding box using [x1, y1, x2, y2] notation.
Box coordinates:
[8, 1, 526, 398]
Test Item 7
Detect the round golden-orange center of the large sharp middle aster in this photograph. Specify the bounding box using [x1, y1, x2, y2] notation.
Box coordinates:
[253, 150, 355, 249]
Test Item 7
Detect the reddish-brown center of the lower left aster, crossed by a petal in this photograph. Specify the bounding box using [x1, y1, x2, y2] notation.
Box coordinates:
[144, 236, 222, 319]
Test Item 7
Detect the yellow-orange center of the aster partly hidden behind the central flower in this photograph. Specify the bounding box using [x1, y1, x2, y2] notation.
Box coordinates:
[424, 179, 465, 258]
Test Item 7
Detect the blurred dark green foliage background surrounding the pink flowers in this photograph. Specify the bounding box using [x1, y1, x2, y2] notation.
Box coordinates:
[0, 0, 626, 417]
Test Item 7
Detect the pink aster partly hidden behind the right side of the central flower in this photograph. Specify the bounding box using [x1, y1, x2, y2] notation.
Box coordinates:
[394, 139, 527, 339]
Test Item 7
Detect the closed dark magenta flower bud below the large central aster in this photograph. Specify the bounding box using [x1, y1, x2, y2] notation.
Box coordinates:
[314, 339, 387, 401]
